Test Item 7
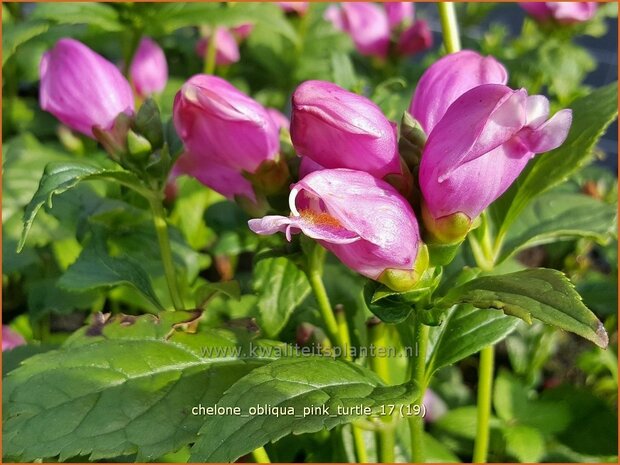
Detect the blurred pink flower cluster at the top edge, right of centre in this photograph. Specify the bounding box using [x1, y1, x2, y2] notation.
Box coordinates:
[325, 2, 433, 58]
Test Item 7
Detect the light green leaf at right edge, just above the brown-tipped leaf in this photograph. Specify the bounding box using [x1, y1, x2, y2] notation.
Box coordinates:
[498, 188, 616, 263]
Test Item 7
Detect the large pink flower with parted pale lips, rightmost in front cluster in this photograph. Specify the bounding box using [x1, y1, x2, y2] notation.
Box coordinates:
[419, 84, 572, 229]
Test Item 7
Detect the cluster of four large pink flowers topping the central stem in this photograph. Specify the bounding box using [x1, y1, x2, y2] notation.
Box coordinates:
[249, 51, 571, 290]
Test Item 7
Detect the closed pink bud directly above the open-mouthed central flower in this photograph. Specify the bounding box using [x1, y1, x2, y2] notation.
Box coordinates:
[291, 81, 401, 178]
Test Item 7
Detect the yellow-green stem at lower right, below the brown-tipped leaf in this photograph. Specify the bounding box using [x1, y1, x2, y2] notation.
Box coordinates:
[472, 346, 494, 463]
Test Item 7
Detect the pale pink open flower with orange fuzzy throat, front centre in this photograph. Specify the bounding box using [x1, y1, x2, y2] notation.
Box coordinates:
[249, 169, 424, 289]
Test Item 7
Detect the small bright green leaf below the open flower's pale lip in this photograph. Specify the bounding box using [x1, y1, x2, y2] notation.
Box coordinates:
[252, 257, 310, 337]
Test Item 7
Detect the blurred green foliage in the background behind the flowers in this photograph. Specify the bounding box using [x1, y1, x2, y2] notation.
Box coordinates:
[2, 3, 618, 462]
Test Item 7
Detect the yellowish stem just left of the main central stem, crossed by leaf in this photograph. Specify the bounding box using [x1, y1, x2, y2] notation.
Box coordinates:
[368, 323, 396, 463]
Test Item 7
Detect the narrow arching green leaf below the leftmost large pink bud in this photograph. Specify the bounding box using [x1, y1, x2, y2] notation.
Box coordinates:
[18, 162, 145, 250]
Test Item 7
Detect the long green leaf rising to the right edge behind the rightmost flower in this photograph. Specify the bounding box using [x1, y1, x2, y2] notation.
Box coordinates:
[491, 82, 618, 239]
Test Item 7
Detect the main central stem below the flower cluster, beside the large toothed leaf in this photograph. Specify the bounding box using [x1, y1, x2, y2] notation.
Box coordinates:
[409, 318, 429, 463]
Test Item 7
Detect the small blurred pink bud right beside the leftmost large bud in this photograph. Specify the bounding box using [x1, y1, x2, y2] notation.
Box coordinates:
[129, 37, 168, 98]
